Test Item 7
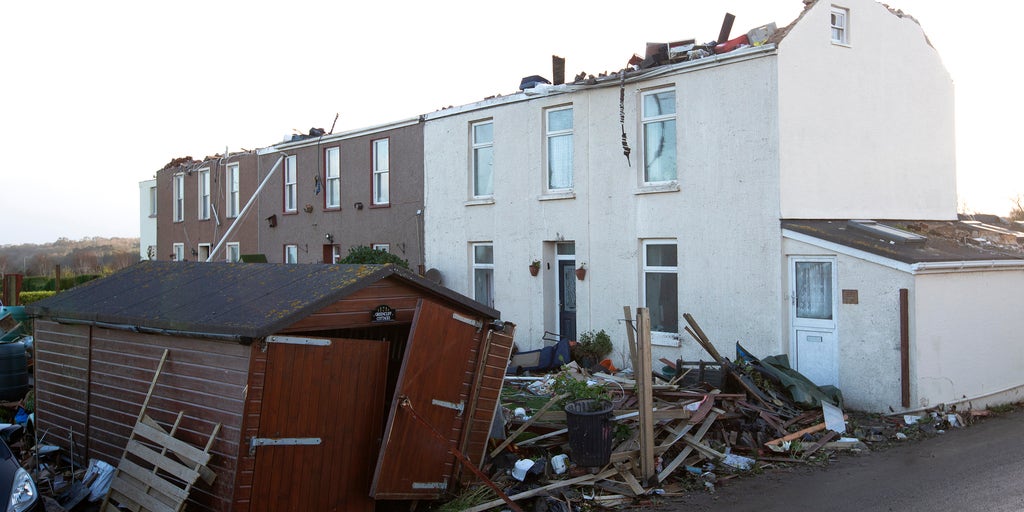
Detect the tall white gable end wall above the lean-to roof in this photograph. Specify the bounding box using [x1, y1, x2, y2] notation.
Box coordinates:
[778, 0, 956, 219]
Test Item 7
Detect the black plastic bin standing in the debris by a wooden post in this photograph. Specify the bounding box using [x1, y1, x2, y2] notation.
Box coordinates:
[565, 399, 614, 467]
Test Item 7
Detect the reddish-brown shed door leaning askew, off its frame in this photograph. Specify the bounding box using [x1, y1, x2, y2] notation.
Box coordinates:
[372, 299, 482, 500]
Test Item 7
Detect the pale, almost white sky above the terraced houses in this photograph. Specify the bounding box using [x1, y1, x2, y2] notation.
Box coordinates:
[0, 0, 1024, 245]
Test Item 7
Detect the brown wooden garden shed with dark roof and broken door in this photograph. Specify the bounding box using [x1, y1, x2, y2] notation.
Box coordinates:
[29, 261, 514, 511]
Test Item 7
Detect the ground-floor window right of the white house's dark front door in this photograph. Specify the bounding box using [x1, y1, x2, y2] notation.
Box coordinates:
[643, 240, 679, 345]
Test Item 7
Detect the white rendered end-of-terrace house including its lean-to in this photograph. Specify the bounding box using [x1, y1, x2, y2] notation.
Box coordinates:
[424, 0, 1024, 411]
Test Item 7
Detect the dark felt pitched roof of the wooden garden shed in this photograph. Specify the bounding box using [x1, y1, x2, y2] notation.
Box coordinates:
[26, 261, 501, 341]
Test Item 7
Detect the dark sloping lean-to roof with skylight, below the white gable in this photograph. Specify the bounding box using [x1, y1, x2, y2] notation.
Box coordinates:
[782, 219, 1024, 264]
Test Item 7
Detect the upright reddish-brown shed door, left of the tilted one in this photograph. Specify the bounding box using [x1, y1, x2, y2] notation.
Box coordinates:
[251, 339, 388, 512]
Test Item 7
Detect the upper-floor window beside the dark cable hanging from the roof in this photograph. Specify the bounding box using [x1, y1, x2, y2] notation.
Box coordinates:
[642, 89, 677, 184]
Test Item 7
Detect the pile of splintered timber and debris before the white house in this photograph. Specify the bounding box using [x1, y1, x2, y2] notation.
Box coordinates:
[450, 309, 982, 512]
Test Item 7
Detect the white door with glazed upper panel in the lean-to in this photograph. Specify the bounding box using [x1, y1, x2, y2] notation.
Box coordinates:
[790, 256, 839, 386]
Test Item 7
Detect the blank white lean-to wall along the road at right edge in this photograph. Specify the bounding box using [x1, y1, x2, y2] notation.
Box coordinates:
[911, 269, 1024, 409]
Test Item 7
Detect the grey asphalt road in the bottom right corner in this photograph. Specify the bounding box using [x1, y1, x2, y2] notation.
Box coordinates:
[656, 408, 1024, 512]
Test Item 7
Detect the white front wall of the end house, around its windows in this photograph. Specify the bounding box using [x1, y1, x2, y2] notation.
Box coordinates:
[424, 52, 781, 364]
